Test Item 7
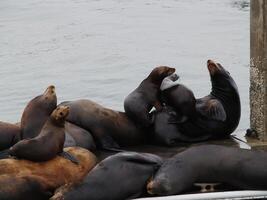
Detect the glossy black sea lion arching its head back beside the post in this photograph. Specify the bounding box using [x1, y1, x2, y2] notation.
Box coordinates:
[161, 60, 241, 138]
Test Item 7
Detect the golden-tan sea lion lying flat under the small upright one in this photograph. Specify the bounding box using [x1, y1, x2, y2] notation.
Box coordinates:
[0, 147, 97, 200]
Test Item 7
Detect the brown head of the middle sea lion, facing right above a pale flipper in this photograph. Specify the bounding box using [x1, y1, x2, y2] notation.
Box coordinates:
[148, 66, 175, 85]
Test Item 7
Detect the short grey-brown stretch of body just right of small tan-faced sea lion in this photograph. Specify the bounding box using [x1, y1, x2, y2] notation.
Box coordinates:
[64, 122, 96, 151]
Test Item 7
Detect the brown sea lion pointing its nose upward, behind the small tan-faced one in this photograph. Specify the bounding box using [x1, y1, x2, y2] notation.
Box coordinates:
[21, 85, 57, 139]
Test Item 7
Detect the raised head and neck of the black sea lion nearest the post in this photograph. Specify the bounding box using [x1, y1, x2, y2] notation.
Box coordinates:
[207, 60, 237, 93]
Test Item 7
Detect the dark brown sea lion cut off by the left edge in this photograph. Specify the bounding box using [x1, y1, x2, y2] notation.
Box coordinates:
[0, 122, 20, 151]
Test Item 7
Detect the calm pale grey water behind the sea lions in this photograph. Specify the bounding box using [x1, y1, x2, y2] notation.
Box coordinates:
[0, 0, 249, 135]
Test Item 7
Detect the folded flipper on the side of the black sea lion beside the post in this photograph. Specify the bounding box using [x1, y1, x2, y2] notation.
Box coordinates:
[198, 99, 226, 122]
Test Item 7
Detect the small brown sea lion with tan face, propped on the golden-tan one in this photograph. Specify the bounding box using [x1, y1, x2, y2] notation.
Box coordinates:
[9, 106, 69, 161]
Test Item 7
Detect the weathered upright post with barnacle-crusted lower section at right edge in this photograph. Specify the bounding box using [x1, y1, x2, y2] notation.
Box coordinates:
[250, 0, 267, 141]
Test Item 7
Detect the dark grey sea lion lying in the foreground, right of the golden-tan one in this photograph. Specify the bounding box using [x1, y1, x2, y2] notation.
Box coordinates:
[51, 152, 162, 200]
